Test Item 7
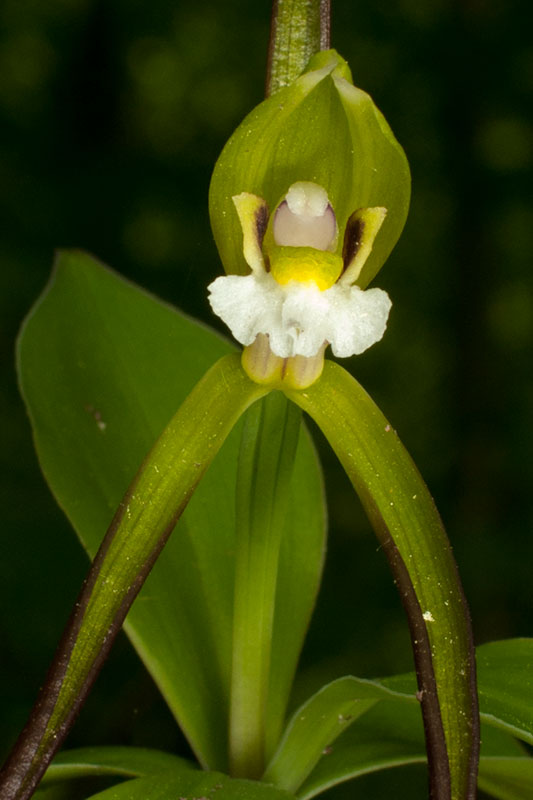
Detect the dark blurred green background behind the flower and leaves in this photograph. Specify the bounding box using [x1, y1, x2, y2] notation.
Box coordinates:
[0, 0, 533, 799]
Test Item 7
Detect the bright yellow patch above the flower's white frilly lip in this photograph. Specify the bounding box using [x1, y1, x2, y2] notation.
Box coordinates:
[269, 247, 343, 292]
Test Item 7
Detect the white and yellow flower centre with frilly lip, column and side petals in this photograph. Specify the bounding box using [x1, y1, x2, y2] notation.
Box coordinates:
[209, 182, 391, 388]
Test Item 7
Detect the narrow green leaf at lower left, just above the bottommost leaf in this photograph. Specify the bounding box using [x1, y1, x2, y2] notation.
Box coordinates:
[42, 747, 197, 785]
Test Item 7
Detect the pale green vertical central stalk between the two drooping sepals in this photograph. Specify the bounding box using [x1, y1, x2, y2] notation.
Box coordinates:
[229, 392, 301, 778]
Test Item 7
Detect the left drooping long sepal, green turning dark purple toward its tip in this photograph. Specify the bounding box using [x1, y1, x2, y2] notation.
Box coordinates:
[0, 354, 267, 800]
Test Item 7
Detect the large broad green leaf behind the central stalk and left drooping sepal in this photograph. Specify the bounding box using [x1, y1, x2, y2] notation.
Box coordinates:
[14, 253, 324, 769]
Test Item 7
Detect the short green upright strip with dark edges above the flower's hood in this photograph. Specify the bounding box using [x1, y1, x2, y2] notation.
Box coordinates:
[266, 0, 331, 97]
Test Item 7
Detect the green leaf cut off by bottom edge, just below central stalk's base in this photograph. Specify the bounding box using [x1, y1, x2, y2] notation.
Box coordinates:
[82, 770, 294, 800]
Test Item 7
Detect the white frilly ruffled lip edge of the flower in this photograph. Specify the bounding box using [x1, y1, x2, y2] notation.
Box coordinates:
[208, 274, 391, 358]
